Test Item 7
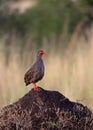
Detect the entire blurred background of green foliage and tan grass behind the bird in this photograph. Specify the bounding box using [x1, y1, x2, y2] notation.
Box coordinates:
[0, 0, 93, 109]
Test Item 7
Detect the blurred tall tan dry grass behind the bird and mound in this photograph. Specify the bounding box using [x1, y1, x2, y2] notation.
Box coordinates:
[0, 28, 93, 109]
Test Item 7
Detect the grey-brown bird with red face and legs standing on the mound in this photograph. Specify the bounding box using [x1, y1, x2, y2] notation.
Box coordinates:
[24, 50, 45, 91]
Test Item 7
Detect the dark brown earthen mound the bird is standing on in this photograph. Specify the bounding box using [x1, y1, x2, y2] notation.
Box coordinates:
[0, 87, 93, 130]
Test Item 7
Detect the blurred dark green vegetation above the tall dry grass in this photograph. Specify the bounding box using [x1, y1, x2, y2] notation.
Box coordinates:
[0, 0, 93, 47]
